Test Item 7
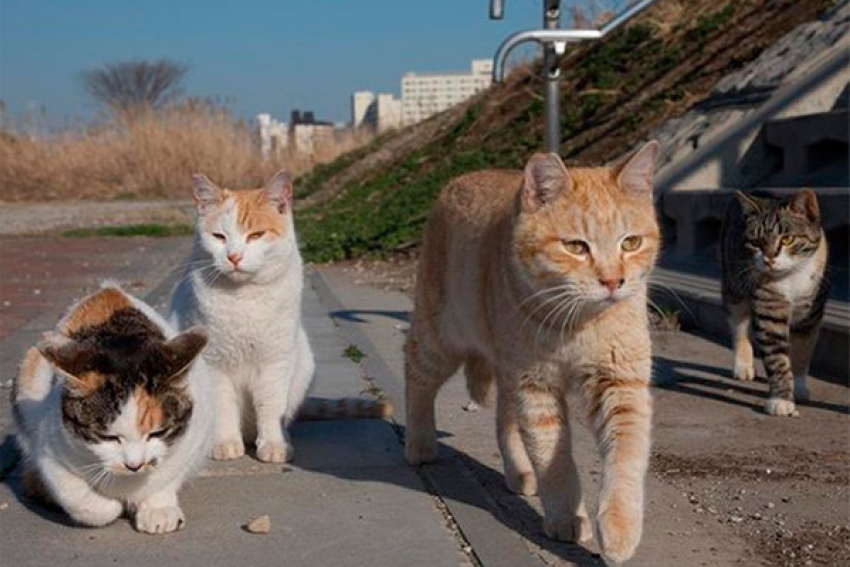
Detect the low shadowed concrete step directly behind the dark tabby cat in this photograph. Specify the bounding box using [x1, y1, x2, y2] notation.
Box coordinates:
[651, 267, 850, 384]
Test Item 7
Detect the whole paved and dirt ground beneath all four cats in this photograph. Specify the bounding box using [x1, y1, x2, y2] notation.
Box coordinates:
[0, 239, 850, 567]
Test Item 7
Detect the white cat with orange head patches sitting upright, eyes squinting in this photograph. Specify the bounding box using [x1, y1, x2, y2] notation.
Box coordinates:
[171, 171, 392, 462]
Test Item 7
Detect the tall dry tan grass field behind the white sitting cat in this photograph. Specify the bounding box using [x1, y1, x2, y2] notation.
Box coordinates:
[0, 102, 367, 201]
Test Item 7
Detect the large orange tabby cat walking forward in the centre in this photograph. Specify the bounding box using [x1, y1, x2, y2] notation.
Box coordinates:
[405, 142, 660, 561]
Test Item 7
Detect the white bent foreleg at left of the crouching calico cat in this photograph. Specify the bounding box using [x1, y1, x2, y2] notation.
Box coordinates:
[38, 457, 124, 527]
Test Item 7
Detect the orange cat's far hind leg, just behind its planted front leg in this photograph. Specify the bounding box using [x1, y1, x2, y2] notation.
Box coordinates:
[496, 392, 537, 496]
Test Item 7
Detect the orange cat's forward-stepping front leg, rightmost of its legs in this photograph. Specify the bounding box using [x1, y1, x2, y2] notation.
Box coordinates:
[585, 370, 652, 563]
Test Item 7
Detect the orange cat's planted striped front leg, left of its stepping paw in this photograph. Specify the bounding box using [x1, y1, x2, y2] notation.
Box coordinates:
[512, 376, 593, 542]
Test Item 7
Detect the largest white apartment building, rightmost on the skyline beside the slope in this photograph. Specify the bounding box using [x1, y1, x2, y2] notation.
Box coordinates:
[401, 59, 493, 126]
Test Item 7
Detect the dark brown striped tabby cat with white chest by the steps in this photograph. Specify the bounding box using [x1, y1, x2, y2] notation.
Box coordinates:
[720, 189, 829, 416]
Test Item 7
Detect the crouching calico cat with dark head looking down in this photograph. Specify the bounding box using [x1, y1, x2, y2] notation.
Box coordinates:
[12, 285, 213, 533]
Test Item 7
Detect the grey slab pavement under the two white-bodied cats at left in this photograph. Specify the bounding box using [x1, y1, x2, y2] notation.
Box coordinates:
[0, 239, 469, 567]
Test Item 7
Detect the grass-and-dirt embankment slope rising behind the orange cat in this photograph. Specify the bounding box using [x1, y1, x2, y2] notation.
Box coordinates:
[298, 0, 831, 261]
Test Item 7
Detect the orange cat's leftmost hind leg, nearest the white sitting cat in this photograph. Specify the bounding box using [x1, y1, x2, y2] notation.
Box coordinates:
[404, 330, 461, 465]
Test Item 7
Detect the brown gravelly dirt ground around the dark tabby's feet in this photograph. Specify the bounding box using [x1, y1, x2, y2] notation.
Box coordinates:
[336, 255, 850, 567]
